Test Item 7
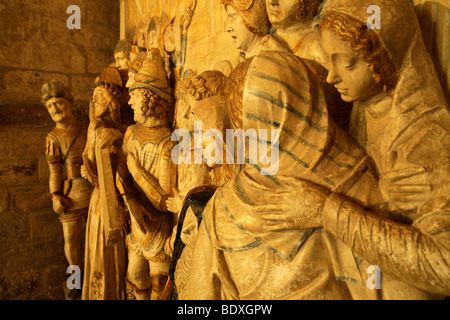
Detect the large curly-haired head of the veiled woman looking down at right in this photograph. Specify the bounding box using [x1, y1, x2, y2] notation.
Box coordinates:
[320, 11, 398, 102]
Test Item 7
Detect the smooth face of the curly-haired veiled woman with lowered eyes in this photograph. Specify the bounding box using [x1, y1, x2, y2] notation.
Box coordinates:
[322, 30, 383, 102]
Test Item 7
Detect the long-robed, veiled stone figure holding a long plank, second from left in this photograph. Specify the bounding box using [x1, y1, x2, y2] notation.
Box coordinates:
[82, 72, 128, 300]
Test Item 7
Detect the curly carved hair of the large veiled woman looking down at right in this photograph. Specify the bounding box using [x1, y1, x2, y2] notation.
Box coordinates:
[320, 11, 398, 95]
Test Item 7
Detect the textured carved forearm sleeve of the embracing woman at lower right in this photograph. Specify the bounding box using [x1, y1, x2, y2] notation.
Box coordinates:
[323, 195, 450, 295]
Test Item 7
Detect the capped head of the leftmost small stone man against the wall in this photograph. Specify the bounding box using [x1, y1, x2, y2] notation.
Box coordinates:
[41, 81, 73, 123]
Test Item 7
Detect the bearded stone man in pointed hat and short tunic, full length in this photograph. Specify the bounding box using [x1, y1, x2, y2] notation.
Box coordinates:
[124, 49, 176, 300]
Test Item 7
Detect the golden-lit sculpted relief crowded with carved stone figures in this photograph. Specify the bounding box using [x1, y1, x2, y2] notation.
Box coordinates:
[43, 0, 450, 300]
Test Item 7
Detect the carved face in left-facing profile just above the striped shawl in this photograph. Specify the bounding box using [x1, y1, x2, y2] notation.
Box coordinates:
[226, 5, 256, 52]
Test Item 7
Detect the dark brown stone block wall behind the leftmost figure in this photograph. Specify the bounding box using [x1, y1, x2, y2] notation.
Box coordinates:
[0, 0, 120, 299]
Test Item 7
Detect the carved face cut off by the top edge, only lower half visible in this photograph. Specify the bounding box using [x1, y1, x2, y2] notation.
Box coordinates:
[265, 0, 298, 28]
